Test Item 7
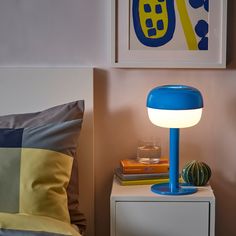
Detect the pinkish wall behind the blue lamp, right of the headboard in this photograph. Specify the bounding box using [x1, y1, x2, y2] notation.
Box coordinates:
[95, 1, 236, 236]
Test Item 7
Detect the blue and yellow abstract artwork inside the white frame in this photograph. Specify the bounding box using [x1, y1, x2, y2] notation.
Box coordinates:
[130, 0, 209, 50]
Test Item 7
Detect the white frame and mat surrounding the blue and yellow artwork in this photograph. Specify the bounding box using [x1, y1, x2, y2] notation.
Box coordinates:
[110, 0, 227, 68]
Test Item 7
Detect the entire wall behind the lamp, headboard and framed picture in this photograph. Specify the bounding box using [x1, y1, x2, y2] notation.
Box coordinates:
[0, 0, 236, 236]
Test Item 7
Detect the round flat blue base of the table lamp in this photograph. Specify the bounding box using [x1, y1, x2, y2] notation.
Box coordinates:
[151, 183, 197, 195]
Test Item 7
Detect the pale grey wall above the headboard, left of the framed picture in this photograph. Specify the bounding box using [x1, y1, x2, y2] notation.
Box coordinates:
[0, 0, 107, 66]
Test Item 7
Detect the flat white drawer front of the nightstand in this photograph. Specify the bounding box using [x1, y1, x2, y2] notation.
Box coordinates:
[115, 202, 210, 236]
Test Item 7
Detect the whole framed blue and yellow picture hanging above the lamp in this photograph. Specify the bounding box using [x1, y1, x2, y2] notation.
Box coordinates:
[111, 0, 227, 68]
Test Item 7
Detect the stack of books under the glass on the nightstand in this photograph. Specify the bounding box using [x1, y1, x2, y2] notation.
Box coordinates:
[115, 158, 173, 185]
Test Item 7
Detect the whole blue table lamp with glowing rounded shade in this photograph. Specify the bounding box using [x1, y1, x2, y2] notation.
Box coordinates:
[147, 85, 203, 195]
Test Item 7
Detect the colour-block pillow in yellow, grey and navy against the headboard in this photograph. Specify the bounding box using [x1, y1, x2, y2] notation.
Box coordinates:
[0, 100, 85, 226]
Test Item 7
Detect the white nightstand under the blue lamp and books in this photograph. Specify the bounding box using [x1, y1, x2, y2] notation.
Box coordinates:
[110, 178, 215, 236]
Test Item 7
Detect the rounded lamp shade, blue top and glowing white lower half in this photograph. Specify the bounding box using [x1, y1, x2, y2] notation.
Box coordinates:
[147, 85, 203, 128]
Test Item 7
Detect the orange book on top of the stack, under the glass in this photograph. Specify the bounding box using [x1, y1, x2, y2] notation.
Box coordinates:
[120, 158, 169, 174]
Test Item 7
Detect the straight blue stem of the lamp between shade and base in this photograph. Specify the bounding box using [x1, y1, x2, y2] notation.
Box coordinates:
[169, 128, 179, 192]
